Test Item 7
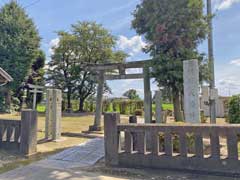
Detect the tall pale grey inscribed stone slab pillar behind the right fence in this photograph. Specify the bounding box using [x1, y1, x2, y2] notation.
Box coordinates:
[183, 60, 201, 123]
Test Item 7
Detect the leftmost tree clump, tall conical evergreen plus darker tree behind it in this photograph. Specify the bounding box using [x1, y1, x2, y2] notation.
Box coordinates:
[0, 1, 45, 112]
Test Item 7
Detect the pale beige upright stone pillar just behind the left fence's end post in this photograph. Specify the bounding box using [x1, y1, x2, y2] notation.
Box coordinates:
[45, 89, 62, 141]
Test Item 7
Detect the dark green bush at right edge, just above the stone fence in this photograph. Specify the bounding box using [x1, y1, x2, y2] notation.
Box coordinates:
[228, 95, 240, 124]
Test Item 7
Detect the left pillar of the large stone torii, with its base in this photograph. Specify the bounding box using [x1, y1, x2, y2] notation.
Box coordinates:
[89, 71, 105, 131]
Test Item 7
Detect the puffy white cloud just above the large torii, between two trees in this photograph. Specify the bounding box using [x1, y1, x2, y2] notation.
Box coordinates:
[117, 36, 147, 56]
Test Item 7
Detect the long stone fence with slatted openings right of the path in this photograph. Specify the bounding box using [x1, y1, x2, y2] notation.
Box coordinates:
[104, 113, 240, 174]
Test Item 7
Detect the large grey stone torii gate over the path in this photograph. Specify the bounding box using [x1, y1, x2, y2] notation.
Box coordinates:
[85, 60, 158, 131]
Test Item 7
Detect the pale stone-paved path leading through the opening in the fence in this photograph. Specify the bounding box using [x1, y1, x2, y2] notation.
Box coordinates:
[0, 138, 127, 180]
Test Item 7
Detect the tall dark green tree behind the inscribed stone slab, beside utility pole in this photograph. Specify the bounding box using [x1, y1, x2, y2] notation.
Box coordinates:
[132, 0, 207, 120]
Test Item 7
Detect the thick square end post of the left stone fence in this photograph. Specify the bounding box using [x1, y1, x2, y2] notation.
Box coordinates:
[20, 110, 37, 156]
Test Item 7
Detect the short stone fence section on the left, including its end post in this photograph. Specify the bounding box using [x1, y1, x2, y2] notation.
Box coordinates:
[0, 110, 37, 155]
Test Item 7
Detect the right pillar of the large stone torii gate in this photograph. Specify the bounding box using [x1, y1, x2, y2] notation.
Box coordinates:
[143, 66, 152, 123]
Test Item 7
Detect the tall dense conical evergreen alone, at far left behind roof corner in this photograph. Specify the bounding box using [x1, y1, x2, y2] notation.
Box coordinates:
[0, 1, 40, 111]
